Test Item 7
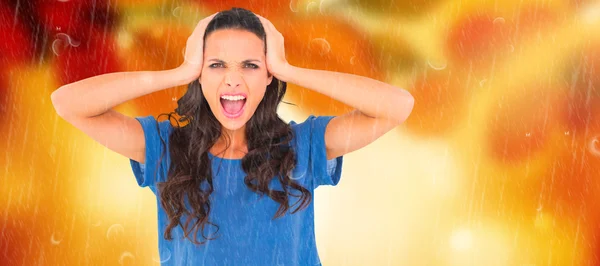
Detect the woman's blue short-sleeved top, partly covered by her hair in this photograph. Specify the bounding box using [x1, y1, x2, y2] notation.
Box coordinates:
[130, 115, 343, 266]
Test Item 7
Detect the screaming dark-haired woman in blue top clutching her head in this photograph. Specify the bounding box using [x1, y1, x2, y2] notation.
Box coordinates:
[52, 8, 413, 265]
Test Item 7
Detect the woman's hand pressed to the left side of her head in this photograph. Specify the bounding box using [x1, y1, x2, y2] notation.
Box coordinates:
[179, 12, 219, 82]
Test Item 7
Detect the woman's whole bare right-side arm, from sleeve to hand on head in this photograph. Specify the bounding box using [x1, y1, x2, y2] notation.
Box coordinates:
[259, 16, 414, 160]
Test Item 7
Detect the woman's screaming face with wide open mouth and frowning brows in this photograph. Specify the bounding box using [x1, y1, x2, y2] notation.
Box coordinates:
[200, 29, 273, 130]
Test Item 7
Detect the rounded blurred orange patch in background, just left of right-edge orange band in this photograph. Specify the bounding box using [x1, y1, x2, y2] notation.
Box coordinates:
[486, 86, 564, 162]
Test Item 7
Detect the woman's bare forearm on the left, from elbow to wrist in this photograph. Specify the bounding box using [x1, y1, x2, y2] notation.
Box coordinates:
[51, 69, 190, 117]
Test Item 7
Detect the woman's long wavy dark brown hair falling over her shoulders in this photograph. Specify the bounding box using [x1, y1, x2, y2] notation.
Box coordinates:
[150, 8, 312, 245]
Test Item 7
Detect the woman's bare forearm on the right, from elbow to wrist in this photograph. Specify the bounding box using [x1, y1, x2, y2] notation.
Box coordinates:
[280, 66, 414, 122]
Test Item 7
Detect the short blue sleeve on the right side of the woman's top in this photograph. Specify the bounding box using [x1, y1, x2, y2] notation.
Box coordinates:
[290, 115, 343, 188]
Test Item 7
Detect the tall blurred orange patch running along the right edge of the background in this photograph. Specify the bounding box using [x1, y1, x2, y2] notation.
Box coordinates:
[545, 44, 600, 217]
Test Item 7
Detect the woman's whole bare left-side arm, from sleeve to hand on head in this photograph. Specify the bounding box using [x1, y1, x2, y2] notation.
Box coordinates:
[51, 13, 216, 163]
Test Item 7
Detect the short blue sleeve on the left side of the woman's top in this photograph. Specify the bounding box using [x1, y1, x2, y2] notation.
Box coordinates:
[129, 116, 170, 187]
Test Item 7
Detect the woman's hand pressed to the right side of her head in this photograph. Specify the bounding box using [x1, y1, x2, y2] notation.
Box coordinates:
[256, 15, 290, 81]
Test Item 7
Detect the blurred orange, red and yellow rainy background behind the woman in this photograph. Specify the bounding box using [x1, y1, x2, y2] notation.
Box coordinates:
[0, 0, 600, 265]
